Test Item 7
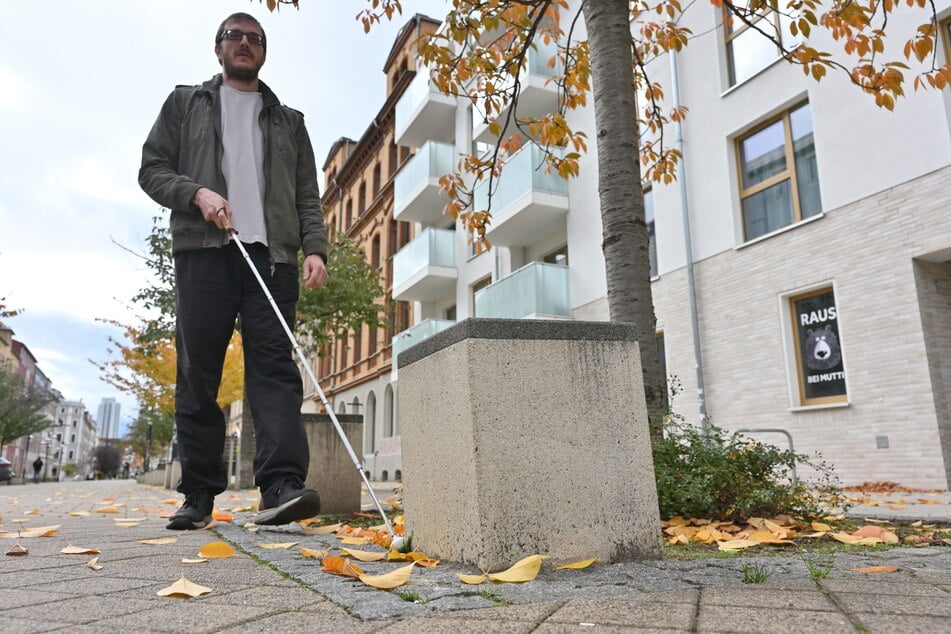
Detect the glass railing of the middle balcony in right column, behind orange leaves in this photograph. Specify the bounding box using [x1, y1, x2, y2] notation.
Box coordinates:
[473, 145, 568, 215]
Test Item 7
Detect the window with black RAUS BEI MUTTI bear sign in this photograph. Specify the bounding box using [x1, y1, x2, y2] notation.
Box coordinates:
[789, 287, 848, 405]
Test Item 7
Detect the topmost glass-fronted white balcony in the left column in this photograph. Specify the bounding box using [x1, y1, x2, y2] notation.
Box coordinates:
[395, 68, 456, 148]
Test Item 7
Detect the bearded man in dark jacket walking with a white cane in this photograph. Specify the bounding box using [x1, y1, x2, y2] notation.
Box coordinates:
[139, 13, 327, 530]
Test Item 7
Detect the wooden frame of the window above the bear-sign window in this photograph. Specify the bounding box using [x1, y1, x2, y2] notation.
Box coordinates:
[733, 101, 823, 243]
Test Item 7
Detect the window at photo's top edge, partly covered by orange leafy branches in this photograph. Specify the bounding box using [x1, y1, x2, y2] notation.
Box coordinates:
[723, 7, 801, 86]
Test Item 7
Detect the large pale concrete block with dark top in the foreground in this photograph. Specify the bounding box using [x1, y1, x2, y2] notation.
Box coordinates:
[398, 319, 662, 571]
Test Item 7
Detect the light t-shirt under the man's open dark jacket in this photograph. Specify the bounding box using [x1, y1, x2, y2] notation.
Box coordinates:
[220, 84, 267, 244]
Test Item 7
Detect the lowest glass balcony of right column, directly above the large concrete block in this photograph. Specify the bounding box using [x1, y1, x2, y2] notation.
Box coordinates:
[475, 262, 571, 319]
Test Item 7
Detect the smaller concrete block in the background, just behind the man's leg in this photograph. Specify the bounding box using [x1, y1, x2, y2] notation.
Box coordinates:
[301, 414, 363, 514]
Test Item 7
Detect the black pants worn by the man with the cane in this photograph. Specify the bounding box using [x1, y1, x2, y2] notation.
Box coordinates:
[175, 243, 310, 494]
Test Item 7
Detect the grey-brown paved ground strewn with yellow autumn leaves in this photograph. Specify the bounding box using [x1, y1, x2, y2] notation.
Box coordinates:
[0, 480, 951, 634]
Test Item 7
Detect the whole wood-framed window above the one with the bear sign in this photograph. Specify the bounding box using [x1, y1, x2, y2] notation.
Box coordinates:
[737, 103, 822, 240]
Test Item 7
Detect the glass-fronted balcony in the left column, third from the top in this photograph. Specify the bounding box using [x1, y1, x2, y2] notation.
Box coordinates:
[393, 229, 457, 302]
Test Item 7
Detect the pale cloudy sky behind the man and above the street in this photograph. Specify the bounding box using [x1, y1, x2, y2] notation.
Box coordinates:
[0, 0, 448, 428]
